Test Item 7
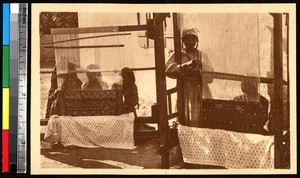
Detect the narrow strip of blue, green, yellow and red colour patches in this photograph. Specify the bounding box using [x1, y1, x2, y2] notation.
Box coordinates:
[2, 3, 10, 173]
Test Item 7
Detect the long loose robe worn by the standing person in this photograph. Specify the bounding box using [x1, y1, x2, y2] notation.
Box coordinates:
[166, 50, 213, 127]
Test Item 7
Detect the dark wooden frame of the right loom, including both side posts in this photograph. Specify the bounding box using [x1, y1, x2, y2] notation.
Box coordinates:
[161, 13, 290, 169]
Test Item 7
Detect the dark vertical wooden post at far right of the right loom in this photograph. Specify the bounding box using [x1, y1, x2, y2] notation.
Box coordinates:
[272, 13, 283, 168]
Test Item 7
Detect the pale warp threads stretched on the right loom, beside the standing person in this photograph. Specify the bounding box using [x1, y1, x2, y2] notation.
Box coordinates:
[179, 13, 260, 101]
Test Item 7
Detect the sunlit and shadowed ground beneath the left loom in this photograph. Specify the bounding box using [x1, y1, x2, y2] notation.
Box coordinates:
[41, 139, 178, 169]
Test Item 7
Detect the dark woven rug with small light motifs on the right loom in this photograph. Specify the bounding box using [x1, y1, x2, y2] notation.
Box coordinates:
[201, 99, 268, 134]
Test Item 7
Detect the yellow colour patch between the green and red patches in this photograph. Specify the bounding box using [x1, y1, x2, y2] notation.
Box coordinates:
[2, 88, 9, 130]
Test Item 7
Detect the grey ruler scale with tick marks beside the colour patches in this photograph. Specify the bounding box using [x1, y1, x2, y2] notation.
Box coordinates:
[17, 3, 28, 173]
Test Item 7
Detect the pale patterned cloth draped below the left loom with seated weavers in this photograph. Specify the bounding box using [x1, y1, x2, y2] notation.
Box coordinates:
[44, 113, 135, 149]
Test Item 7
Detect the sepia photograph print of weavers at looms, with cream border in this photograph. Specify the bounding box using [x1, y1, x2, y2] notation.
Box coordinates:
[31, 4, 297, 174]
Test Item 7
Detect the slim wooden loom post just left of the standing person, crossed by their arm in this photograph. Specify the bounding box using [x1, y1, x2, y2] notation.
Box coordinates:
[173, 13, 186, 124]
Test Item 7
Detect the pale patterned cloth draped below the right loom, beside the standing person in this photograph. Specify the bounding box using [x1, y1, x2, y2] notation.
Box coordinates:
[178, 125, 274, 169]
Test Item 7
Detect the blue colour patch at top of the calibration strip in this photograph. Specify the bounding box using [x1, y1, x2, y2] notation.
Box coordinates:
[3, 3, 10, 45]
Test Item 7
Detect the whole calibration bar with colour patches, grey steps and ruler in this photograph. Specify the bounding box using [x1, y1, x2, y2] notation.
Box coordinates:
[2, 3, 28, 173]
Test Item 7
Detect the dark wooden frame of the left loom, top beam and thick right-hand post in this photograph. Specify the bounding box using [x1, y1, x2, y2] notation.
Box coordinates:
[40, 14, 167, 144]
